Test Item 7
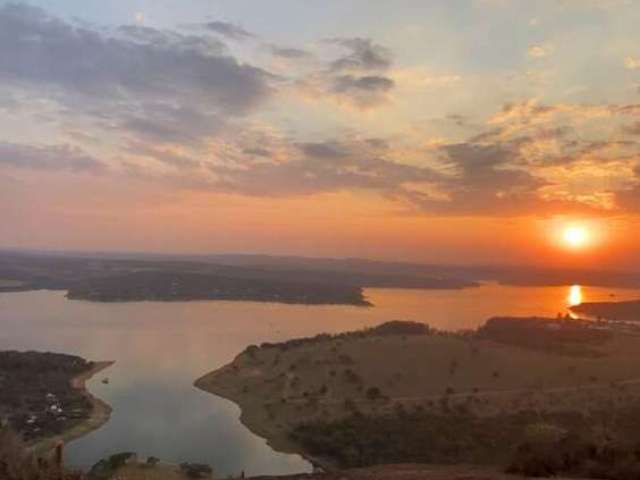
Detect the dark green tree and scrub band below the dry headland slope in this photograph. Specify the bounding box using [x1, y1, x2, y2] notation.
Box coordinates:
[291, 404, 640, 480]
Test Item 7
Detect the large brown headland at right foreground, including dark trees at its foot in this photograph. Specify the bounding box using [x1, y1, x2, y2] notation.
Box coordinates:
[195, 318, 640, 478]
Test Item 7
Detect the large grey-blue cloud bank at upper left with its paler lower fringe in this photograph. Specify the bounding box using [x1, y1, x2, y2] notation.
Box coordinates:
[0, 4, 274, 150]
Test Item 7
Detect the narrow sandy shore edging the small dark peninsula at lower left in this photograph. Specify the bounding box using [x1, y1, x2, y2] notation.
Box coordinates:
[31, 361, 115, 453]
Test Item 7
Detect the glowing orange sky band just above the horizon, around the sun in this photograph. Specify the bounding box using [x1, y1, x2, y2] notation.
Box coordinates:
[3, 172, 640, 269]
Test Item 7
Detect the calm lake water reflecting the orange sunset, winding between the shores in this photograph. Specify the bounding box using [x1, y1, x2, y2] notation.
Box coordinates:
[0, 285, 640, 476]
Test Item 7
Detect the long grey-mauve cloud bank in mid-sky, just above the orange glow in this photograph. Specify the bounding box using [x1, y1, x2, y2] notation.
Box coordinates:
[200, 133, 586, 216]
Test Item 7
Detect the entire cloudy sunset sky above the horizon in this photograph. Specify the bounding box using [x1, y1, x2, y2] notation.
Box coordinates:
[0, 0, 640, 269]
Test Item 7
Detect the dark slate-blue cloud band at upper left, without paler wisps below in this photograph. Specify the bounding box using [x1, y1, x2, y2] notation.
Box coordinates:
[0, 4, 268, 111]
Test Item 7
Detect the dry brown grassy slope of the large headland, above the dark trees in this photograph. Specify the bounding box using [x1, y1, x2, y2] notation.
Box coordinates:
[197, 324, 640, 451]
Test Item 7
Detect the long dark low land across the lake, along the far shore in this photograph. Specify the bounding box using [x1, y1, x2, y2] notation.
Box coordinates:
[0, 251, 479, 307]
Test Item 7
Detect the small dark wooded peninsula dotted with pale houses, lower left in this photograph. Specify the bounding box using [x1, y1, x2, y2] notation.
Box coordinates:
[0, 351, 112, 451]
